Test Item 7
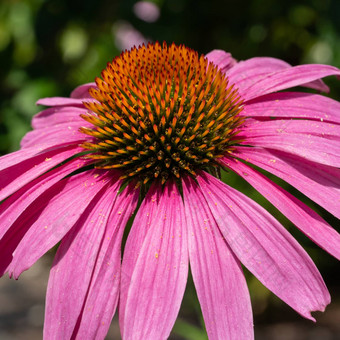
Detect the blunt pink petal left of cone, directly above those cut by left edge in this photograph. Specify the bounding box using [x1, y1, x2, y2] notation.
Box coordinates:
[20, 120, 90, 148]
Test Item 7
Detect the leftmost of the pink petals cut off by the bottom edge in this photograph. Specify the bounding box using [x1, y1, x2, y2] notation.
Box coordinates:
[44, 178, 119, 340]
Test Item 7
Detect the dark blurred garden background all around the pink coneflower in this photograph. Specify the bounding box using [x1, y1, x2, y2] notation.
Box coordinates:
[0, 0, 340, 340]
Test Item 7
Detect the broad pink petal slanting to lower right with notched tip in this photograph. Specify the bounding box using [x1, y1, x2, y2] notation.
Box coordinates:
[197, 174, 330, 320]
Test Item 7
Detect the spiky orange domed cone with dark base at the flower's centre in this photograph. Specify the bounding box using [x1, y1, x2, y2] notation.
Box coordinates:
[80, 43, 242, 184]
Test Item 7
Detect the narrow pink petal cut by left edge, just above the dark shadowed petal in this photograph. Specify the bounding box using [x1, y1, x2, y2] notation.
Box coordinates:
[0, 159, 88, 239]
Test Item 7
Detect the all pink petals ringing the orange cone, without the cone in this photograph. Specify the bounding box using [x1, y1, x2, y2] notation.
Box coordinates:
[0, 43, 340, 340]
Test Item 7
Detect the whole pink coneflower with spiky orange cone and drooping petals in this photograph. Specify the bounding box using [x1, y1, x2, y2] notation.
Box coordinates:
[0, 43, 340, 340]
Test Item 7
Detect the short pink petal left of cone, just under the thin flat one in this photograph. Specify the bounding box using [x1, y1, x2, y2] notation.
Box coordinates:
[32, 106, 88, 129]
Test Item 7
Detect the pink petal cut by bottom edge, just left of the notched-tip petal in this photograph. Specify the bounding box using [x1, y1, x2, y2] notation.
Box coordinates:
[183, 178, 254, 340]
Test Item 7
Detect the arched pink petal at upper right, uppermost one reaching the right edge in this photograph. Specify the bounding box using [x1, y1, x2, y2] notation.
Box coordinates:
[239, 64, 340, 100]
